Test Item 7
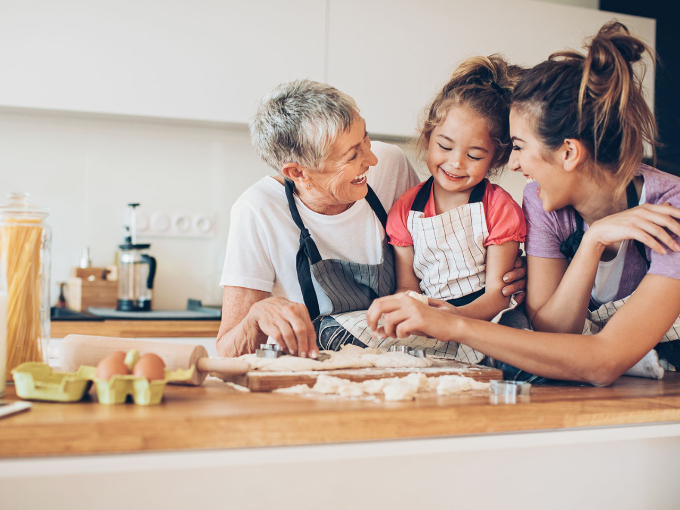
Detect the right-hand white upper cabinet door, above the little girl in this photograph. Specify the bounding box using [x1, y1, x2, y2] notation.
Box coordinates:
[328, 0, 655, 136]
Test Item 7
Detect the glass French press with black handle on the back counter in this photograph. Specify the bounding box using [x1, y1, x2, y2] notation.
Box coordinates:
[116, 204, 156, 312]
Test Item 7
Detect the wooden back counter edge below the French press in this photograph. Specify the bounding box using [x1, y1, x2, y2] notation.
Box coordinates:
[50, 319, 220, 338]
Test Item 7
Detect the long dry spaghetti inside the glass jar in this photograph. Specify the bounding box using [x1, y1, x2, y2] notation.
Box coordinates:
[0, 219, 43, 379]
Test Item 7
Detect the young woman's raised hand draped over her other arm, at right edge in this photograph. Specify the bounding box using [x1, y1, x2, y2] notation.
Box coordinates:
[583, 203, 680, 255]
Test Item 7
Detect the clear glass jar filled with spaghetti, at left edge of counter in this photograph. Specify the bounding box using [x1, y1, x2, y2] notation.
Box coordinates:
[0, 193, 52, 380]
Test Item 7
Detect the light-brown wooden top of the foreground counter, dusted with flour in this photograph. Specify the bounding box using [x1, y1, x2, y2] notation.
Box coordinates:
[0, 373, 680, 457]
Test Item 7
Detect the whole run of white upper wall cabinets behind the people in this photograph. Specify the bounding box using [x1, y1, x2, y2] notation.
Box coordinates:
[0, 0, 655, 136]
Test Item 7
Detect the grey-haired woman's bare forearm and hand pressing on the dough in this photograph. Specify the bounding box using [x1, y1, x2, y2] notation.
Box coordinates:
[216, 287, 319, 358]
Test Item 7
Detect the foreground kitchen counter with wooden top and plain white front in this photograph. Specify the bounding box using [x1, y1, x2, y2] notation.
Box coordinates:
[0, 373, 680, 510]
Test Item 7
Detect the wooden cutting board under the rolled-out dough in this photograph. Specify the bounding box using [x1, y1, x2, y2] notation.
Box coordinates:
[233, 360, 503, 391]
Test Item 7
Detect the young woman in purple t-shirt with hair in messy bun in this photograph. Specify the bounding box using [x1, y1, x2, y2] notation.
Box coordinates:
[367, 23, 680, 385]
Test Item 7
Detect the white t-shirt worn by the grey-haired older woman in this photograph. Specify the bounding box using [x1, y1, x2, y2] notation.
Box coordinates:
[220, 142, 420, 310]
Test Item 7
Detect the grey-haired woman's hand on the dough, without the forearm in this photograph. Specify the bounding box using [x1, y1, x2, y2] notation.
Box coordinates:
[247, 297, 319, 358]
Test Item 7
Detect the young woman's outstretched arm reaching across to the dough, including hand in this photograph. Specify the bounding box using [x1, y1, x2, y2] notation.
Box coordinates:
[367, 275, 680, 386]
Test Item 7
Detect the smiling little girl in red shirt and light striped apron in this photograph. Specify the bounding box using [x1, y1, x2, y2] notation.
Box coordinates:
[387, 55, 526, 363]
